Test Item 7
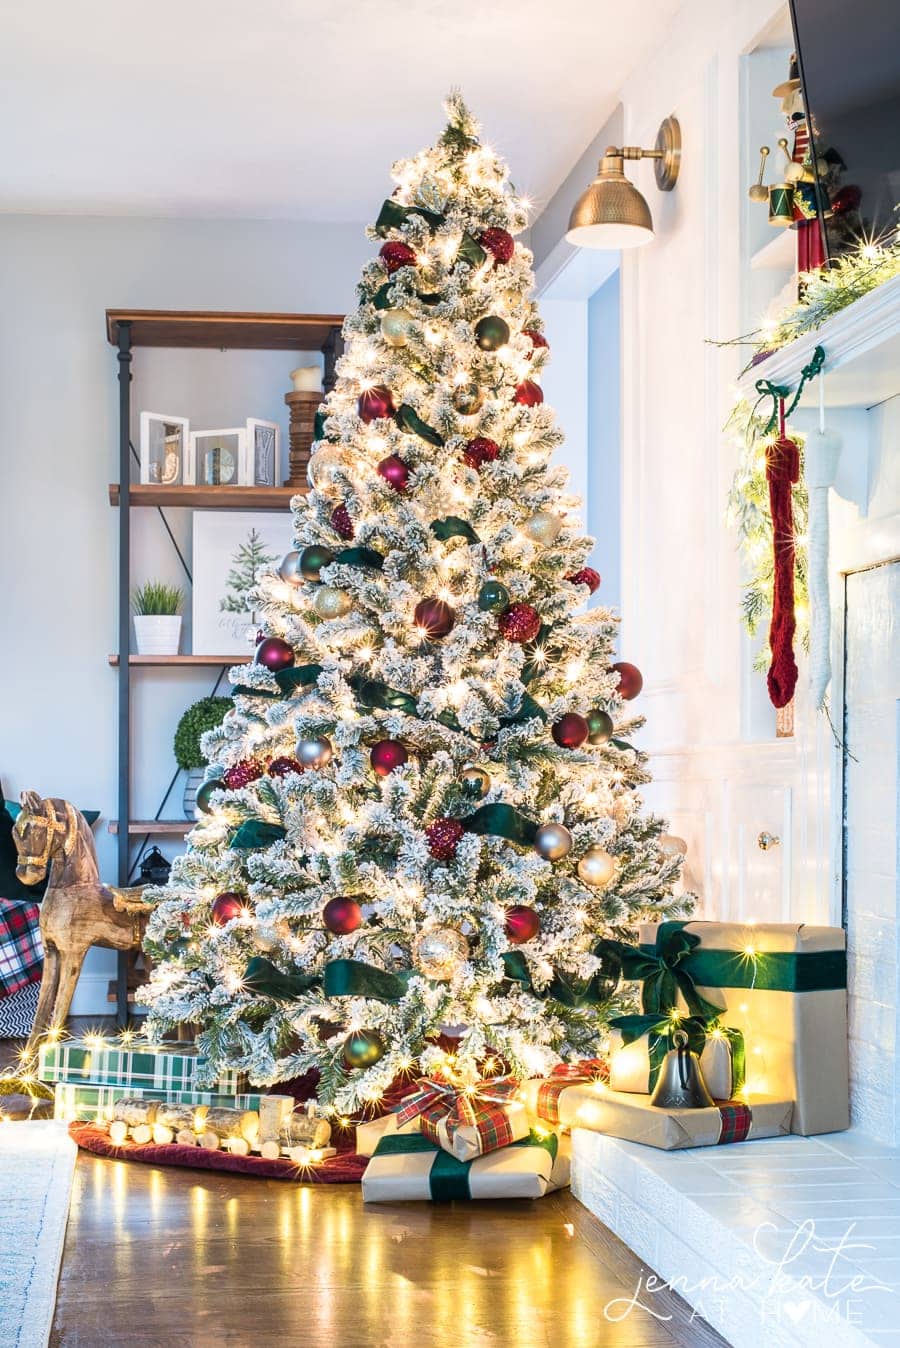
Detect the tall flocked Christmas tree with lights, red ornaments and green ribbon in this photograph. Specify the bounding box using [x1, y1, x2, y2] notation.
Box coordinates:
[147, 97, 680, 1111]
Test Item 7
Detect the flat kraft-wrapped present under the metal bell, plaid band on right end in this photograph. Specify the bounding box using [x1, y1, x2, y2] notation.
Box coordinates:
[565, 1085, 794, 1151]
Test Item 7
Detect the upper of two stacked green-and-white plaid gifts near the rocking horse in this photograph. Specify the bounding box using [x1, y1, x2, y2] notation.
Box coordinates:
[38, 1038, 248, 1095]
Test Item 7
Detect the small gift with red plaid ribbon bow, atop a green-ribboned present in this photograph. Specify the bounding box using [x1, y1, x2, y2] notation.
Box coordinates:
[396, 1077, 529, 1161]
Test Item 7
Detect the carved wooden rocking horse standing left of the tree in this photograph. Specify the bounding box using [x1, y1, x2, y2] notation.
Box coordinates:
[12, 791, 152, 1055]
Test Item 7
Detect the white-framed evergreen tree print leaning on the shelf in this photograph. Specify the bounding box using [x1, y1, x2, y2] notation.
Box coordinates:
[191, 510, 294, 655]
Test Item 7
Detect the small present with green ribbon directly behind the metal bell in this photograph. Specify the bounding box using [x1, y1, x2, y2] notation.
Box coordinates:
[609, 1015, 746, 1100]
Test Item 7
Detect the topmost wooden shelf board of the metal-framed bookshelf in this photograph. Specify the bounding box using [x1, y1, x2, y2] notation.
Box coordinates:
[106, 309, 344, 350]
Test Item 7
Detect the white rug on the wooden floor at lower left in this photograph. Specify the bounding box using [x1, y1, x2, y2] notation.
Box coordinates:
[0, 1119, 78, 1348]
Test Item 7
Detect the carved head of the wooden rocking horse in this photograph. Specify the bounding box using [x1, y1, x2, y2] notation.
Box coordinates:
[12, 791, 97, 884]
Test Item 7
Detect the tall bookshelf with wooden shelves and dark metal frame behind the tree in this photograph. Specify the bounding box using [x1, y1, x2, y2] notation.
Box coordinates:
[106, 309, 344, 1024]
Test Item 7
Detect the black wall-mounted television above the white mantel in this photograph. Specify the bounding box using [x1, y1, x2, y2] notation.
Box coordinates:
[791, 0, 900, 259]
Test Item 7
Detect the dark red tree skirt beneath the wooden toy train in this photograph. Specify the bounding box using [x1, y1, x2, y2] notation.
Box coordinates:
[69, 1123, 369, 1184]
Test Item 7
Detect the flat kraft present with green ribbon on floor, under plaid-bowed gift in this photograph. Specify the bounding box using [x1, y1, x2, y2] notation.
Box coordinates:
[362, 1132, 569, 1202]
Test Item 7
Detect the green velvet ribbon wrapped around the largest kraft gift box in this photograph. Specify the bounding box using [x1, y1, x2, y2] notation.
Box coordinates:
[638, 921, 847, 997]
